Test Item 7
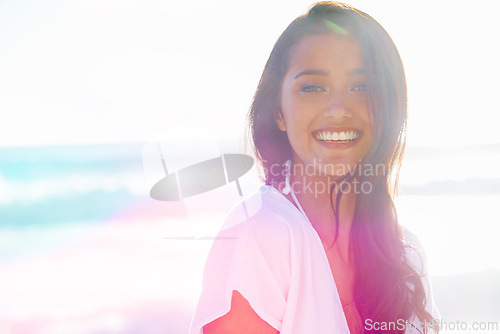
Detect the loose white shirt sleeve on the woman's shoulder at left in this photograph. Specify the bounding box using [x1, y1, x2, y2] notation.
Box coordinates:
[190, 204, 290, 334]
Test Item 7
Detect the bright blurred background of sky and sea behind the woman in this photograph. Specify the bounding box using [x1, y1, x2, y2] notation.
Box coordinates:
[0, 0, 500, 334]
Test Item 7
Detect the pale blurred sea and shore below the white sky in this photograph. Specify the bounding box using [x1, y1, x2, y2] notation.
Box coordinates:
[0, 143, 500, 334]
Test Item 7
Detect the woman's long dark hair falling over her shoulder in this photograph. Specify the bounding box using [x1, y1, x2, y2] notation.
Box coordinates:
[248, 2, 432, 333]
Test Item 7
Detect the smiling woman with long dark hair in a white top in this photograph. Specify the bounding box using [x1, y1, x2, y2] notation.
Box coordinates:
[191, 2, 438, 334]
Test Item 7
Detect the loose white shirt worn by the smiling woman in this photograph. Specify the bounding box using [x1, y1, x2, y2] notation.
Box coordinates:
[190, 186, 439, 334]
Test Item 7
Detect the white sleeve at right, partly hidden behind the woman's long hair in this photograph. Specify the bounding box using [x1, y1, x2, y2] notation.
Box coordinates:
[403, 228, 441, 334]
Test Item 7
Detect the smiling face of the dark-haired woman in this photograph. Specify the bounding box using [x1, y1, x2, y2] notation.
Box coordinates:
[275, 34, 373, 175]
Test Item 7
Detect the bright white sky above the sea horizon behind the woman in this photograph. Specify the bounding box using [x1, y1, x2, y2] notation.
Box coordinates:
[0, 0, 500, 147]
